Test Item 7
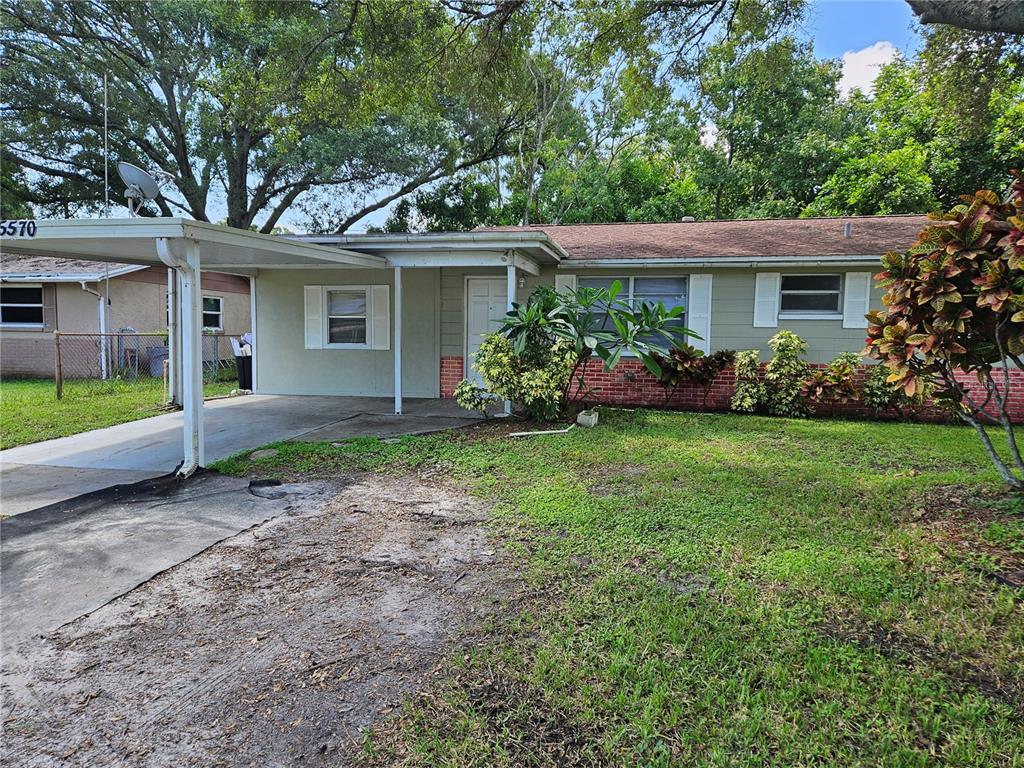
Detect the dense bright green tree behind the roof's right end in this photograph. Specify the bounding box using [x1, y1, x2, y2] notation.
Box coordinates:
[804, 27, 1024, 216]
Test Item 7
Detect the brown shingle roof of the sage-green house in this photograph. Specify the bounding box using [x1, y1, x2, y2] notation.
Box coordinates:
[485, 215, 928, 260]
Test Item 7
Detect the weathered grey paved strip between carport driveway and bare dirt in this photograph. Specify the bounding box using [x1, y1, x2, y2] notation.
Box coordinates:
[0, 471, 323, 663]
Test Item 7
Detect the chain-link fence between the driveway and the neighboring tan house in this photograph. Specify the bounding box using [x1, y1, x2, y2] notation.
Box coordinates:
[53, 332, 238, 401]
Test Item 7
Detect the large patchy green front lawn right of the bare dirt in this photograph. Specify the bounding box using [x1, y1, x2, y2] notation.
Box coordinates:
[209, 412, 1024, 766]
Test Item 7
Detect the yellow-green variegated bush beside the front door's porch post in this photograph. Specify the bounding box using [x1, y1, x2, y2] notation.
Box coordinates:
[456, 332, 575, 421]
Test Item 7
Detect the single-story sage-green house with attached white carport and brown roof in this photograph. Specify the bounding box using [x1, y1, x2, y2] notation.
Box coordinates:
[0, 216, 946, 473]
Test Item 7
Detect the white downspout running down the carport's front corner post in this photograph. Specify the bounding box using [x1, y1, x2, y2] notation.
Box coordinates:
[157, 238, 205, 477]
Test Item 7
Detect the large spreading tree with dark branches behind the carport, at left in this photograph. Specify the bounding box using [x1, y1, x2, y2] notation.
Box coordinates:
[2, 0, 529, 231]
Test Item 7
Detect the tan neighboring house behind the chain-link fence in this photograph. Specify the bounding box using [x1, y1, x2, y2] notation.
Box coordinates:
[0, 253, 250, 378]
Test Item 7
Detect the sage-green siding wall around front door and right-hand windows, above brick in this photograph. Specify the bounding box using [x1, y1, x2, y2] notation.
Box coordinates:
[441, 267, 882, 362]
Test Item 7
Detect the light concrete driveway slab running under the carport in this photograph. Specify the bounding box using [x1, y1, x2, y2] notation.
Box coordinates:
[0, 394, 476, 515]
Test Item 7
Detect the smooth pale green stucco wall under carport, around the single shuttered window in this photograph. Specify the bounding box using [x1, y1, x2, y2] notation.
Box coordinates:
[256, 268, 440, 397]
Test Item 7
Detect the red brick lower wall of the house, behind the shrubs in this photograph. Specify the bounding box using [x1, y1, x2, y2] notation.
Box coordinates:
[441, 356, 1024, 424]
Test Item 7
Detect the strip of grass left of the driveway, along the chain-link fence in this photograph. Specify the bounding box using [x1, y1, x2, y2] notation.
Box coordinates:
[0, 378, 237, 449]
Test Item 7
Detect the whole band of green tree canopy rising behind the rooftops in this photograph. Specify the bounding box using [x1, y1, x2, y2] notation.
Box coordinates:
[0, 0, 1024, 231]
